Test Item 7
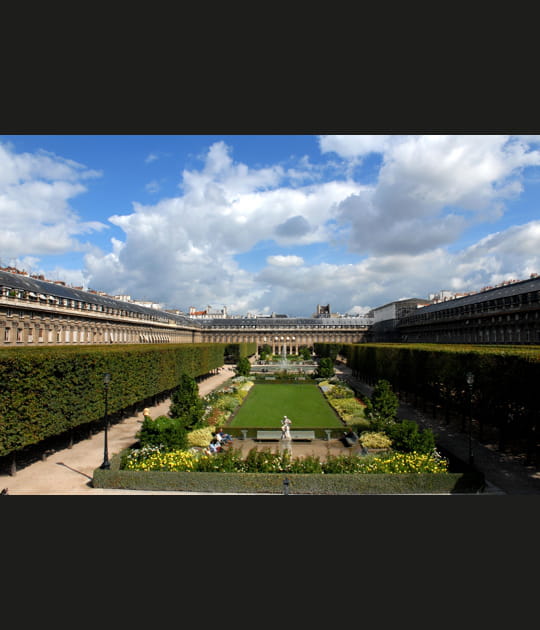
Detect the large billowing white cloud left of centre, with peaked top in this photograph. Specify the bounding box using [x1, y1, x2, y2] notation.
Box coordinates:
[86, 142, 361, 309]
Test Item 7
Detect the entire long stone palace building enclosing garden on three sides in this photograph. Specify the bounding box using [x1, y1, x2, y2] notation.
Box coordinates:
[4, 270, 540, 354]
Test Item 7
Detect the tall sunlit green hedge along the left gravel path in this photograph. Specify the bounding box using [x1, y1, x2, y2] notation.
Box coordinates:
[0, 343, 225, 456]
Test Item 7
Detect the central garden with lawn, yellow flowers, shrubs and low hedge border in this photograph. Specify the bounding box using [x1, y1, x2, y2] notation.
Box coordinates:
[94, 368, 486, 494]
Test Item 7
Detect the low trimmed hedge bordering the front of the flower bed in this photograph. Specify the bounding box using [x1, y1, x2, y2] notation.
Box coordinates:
[92, 453, 484, 495]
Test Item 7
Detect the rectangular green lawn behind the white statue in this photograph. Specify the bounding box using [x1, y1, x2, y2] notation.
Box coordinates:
[230, 383, 343, 429]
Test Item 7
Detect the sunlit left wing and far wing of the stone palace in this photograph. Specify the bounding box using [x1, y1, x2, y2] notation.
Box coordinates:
[0, 270, 370, 354]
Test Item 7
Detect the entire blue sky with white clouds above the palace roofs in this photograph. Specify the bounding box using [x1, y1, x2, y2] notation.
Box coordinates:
[0, 134, 540, 317]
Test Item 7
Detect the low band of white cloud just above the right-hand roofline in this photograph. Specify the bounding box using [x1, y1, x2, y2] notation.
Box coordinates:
[244, 221, 540, 315]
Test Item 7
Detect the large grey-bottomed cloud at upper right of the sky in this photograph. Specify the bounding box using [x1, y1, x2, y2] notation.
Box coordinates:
[338, 135, 540, 254]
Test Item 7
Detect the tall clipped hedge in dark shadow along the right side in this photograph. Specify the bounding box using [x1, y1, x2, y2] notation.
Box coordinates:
[341, 344, 540, 457]
